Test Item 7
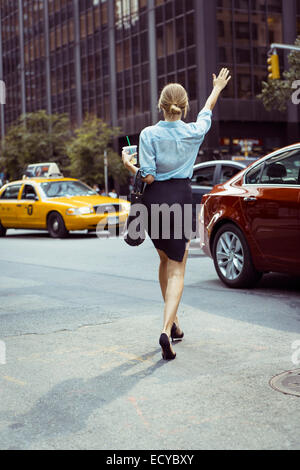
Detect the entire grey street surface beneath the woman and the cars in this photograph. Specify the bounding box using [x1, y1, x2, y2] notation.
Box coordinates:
[0, 230, 300, 450]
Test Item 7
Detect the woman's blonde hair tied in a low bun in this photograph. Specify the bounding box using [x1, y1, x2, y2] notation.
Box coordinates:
[158, 83, 189, 117]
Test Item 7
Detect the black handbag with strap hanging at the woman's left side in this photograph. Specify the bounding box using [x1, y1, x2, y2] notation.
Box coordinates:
[123, 170, 146, 246]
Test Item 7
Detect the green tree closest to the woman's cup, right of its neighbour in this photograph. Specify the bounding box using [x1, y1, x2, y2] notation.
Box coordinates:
[68, 116, 128, 185]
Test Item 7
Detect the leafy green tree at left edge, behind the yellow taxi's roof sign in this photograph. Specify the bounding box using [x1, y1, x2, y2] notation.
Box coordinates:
[2, 110, 72, 179]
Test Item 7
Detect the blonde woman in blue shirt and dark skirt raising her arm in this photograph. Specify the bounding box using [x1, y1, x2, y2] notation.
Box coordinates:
[122, 68, 231, 360]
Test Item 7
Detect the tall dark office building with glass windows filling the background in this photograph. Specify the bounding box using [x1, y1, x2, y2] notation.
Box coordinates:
[0, 0, 300, 155]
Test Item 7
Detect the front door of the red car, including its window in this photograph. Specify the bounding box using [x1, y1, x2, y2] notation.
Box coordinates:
[241, 148, 300, 273]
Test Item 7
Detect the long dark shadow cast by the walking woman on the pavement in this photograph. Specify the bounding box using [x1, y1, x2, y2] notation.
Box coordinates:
[0, 349, 168, 450]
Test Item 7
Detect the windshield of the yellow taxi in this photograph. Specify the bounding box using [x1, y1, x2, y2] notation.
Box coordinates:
[41, 181, 97, 197]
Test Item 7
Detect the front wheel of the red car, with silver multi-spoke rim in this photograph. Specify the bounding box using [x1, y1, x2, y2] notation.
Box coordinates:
[212, 224, 263, 288]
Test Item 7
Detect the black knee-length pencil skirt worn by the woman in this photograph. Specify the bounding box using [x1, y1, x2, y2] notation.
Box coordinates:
[143, 179, 193, 262]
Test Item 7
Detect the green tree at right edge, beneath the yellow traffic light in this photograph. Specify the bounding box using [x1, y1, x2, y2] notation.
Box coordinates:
[258, 36, 300, 111]
